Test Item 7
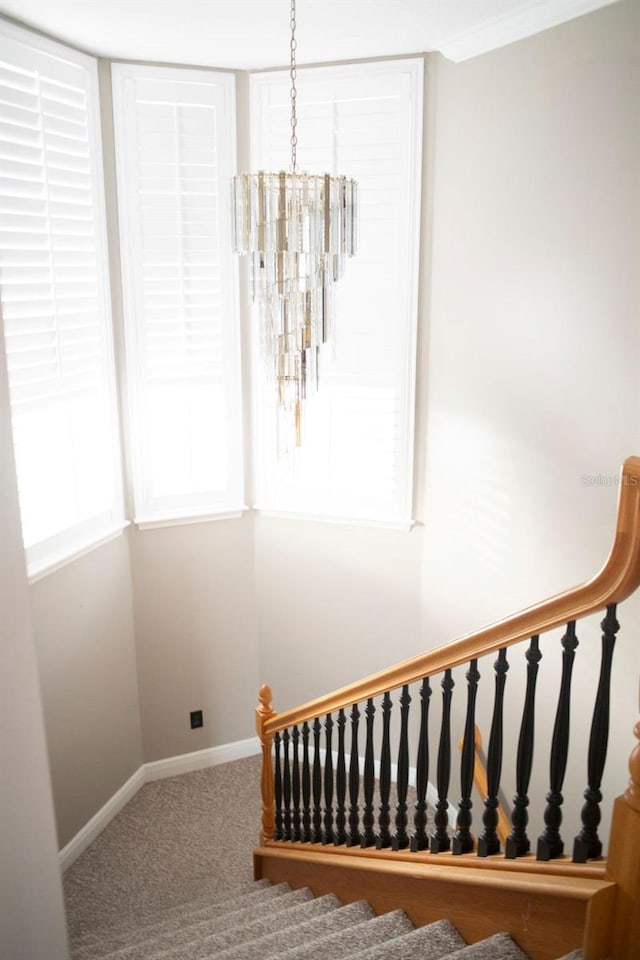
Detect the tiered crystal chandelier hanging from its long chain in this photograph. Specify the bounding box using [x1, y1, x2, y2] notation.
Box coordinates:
[232, 0, 358, 452]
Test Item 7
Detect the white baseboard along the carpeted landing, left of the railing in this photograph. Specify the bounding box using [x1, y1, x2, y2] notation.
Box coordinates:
[58, 737, 260, 871]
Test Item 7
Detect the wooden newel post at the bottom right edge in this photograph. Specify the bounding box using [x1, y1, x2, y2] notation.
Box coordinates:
[607, 722, 640, 960]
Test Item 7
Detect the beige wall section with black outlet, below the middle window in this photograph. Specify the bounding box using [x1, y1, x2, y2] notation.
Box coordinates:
[132, 517, 258, 763]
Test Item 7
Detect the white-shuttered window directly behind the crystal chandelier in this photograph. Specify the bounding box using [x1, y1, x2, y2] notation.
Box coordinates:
[252, 60, 423, 526]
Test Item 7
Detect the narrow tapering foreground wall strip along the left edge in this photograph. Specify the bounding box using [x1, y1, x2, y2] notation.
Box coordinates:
[0, 333, 68, 960]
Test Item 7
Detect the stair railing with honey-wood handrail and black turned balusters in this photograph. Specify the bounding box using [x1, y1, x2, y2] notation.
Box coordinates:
[256, 457, 640, 956]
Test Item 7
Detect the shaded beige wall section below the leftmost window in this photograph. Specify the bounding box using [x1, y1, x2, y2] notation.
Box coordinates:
[31, 534, 143, 847]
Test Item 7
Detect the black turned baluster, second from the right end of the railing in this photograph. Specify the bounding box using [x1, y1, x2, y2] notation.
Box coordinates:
[536, 620, 578, 860]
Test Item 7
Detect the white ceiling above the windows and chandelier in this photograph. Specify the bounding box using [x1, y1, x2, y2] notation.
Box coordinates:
[0, 0, 616, 70]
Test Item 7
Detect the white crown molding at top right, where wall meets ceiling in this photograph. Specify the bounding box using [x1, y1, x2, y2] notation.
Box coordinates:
[440, 0, 618, 63]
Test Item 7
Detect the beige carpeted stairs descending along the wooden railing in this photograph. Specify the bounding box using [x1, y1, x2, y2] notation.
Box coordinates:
[72, 880, 581, 960]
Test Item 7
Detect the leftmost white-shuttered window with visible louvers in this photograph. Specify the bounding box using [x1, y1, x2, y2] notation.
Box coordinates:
[0, 24, 123, 576]
